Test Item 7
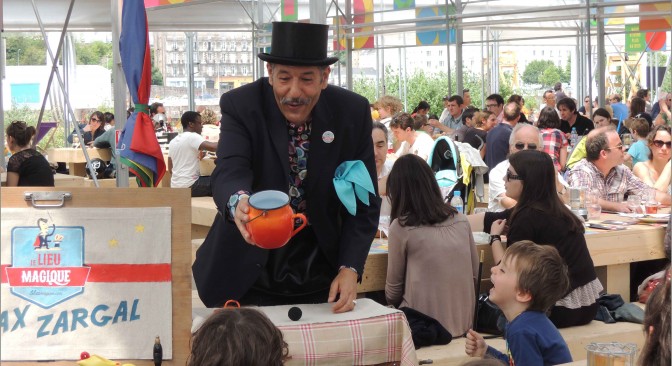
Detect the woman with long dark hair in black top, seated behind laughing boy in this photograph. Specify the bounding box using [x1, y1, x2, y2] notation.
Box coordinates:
[469, 150, 603, 328]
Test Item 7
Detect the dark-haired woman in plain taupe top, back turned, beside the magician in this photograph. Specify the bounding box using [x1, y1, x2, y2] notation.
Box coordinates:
[385, 155, 478, 336]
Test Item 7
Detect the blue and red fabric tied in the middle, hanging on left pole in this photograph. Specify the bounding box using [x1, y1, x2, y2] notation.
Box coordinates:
[117, 0, 166, 187]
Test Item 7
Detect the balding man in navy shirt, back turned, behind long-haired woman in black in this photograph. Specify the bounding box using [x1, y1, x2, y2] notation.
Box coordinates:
[485, 101, 520, 169]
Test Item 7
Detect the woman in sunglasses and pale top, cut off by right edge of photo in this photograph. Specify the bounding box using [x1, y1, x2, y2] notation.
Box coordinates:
[632, 126, 672, 193]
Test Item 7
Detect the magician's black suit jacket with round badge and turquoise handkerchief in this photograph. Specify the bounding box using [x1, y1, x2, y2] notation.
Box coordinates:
[192, 78, 380, 307]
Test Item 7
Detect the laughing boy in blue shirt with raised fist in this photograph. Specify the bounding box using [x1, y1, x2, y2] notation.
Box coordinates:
[465, 240, 572, 366]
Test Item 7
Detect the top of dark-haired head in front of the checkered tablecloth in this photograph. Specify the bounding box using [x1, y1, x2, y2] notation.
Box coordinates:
[187, 307, 289, 366]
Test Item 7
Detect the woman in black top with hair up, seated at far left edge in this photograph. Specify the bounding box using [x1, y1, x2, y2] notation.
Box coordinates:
[7, 121, 54, 187]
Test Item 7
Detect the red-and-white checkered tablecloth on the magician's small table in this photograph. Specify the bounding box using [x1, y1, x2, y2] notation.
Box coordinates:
[259, 299, 418, 366]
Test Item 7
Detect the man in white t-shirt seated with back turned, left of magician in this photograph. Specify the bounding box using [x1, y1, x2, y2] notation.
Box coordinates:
[168, 111, 217, 197]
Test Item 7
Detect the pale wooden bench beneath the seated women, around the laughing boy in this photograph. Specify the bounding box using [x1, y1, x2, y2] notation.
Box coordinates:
[416, 321, 645, 365]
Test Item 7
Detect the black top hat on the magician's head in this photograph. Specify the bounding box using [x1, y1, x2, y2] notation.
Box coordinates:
[257, 22, 338, 66]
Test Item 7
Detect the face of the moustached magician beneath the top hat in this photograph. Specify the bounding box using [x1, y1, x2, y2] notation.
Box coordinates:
[266, 63, 331, 125]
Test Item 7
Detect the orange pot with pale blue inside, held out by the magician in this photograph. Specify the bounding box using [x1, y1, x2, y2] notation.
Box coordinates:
[246, 190, 308, 249]
